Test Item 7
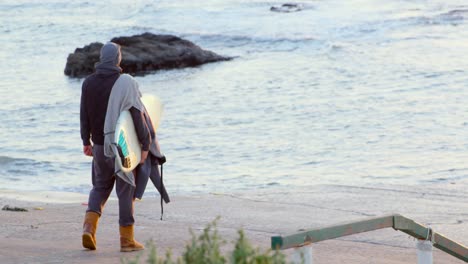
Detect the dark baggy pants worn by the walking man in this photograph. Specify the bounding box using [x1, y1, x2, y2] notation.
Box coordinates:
[86, 145, 135, 226]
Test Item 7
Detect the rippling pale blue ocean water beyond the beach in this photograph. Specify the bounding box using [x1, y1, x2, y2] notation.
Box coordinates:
[0, 0, 468, 194]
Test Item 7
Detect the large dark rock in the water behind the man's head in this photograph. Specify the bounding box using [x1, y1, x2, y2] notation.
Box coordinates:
[64, 33, 232, 77]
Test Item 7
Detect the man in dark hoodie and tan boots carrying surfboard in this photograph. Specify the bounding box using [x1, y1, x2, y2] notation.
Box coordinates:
[80, 42, 151, 252]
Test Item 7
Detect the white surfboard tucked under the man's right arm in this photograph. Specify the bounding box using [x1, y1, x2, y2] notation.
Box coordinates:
[114, 94, 163, 173]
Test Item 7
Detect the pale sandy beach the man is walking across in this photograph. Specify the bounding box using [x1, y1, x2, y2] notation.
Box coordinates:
[0, 184, 468, 264]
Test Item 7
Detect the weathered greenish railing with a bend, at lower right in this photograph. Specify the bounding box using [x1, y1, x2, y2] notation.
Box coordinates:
[271, 214, 468, 263]
